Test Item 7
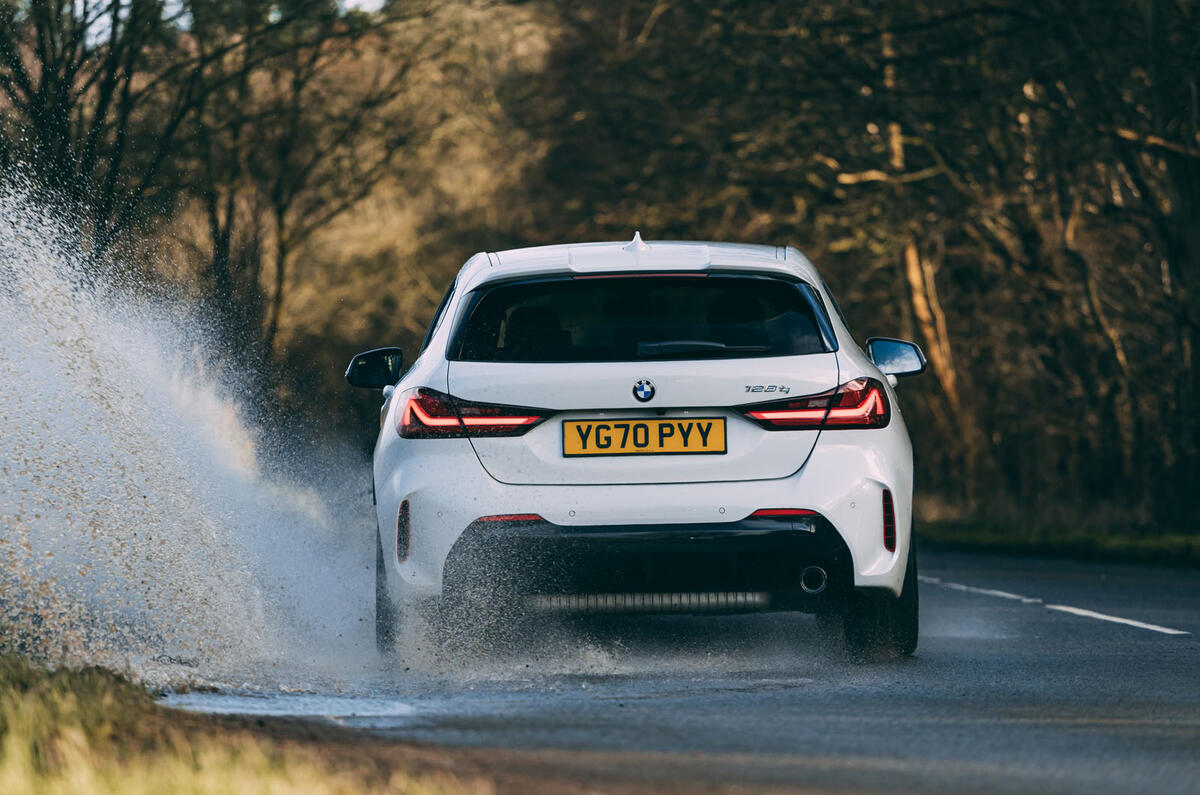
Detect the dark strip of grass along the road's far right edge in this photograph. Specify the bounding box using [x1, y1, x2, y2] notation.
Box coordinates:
[916, 521, 1200, 568]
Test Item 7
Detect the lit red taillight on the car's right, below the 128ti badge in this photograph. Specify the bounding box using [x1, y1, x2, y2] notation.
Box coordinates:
[738, 378, 892, 431]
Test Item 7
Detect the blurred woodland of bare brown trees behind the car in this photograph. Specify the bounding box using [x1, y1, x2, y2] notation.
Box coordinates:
[0, 0, 1200, 534]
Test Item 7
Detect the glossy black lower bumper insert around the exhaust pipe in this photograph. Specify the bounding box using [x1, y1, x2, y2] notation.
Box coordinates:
[443, 516, 853, 612]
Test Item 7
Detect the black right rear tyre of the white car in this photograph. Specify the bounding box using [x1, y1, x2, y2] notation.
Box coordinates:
[844, 543, 920, 660]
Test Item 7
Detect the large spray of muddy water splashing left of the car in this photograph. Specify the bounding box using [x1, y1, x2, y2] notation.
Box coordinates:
[0, 181, 373, 682]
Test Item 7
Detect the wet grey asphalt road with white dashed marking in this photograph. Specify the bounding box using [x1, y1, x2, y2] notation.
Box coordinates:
[172, 550, 1200, 793]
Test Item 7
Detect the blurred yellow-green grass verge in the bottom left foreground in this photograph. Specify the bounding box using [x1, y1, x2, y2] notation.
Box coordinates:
[0, 653, 490, 795]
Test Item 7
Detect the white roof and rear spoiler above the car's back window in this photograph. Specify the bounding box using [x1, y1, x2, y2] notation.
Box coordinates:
[453, 234, 816, 288]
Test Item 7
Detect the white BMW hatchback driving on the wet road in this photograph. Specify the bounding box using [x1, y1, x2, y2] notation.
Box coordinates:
[346, 237, 925, 657]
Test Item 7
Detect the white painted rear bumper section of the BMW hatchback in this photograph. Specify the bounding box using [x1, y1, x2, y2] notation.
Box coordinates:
[376, 429, 912, 600]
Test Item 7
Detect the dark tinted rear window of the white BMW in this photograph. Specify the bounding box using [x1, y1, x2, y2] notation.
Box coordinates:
[450, 274, 830, 363]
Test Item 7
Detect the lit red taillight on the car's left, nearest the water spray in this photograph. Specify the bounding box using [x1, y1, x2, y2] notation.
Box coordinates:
[396, 387, 550, 438]
